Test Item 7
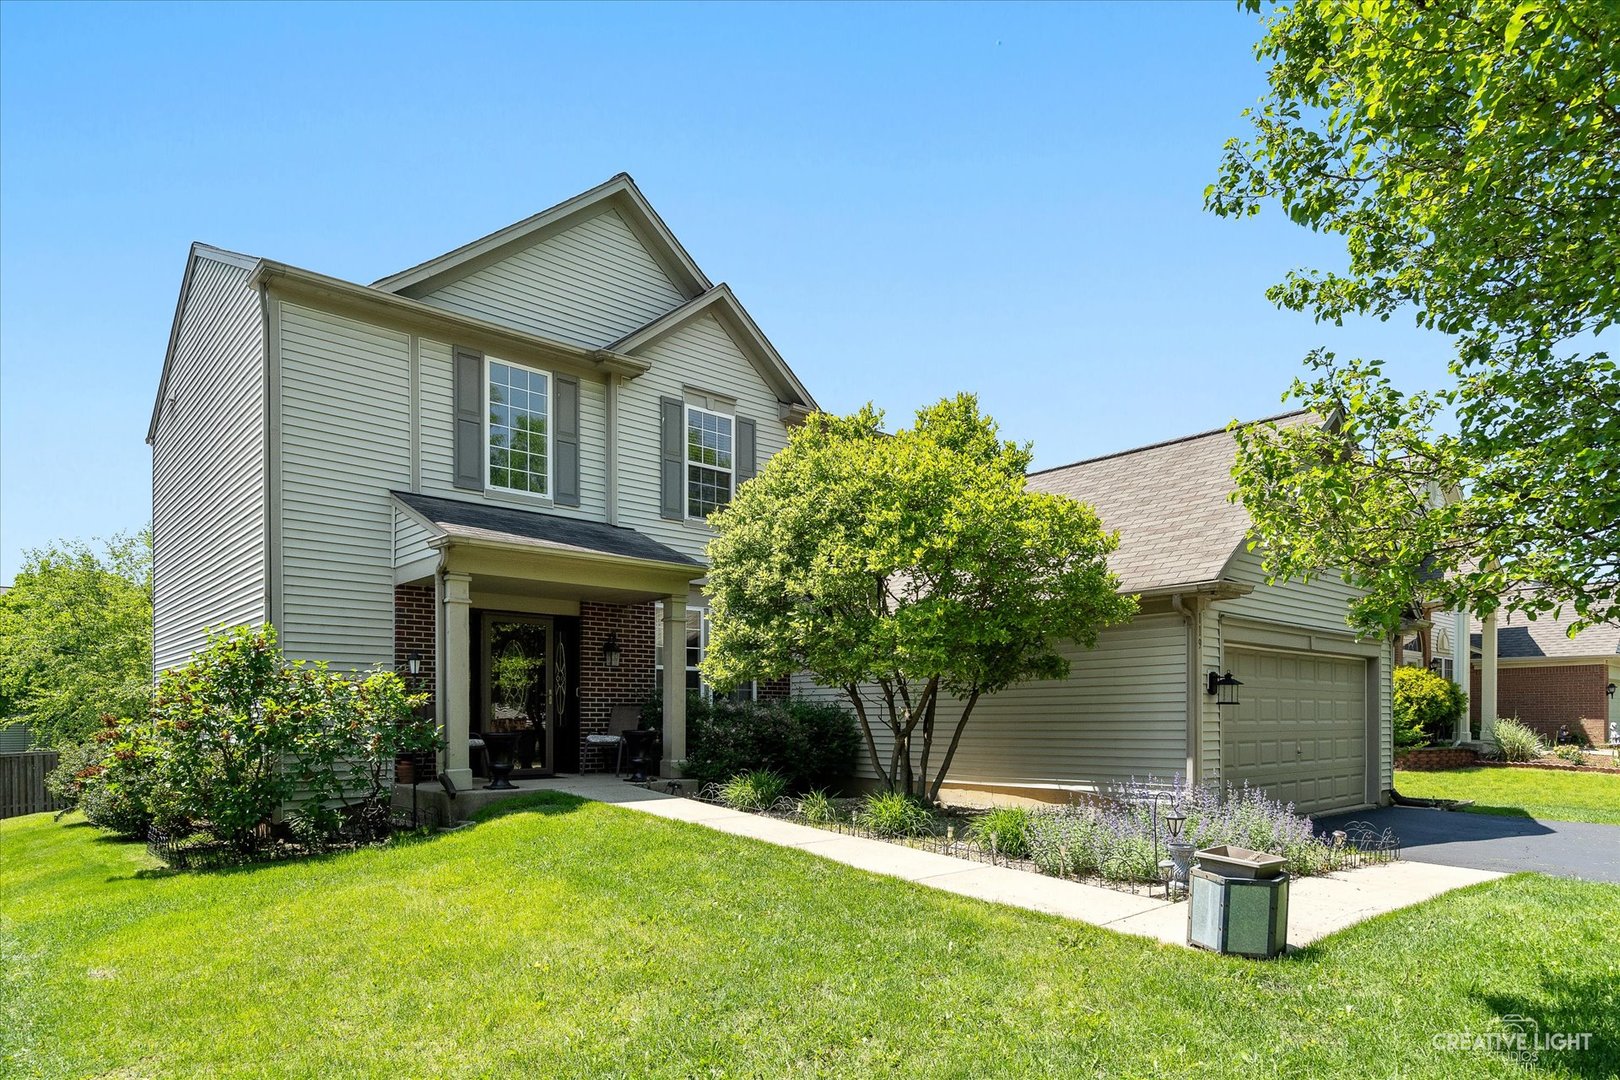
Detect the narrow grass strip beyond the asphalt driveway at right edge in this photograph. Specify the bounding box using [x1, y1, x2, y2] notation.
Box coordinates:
[1395, 767, 1620, 826]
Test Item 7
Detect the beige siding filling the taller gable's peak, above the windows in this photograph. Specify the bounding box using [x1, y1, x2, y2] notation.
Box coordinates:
[421, 209, 687, 347]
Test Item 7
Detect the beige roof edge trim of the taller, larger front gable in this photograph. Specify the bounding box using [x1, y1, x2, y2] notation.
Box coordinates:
[371, 173, 713, 298]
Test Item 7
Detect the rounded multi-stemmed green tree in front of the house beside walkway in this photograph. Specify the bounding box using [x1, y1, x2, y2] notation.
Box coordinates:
[703, 395, 1136, 801]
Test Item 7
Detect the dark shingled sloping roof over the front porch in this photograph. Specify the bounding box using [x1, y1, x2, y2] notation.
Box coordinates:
[390, 491, 703, 568]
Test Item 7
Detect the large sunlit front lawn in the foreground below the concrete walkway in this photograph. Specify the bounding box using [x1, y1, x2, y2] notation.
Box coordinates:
[0, 795, 1620, 1077]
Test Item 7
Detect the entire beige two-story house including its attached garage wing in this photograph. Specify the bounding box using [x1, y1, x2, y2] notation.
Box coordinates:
[149, 175, 1392, 811]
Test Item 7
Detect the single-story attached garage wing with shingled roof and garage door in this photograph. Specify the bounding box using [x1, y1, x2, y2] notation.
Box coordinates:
[800, 413, 1393, 813]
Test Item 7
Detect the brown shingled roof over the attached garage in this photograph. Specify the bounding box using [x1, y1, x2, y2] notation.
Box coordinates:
[1029, 411, 1311, 593]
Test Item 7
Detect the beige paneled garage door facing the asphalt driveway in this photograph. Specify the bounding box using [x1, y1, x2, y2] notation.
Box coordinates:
[1220, 649, 1367, 814]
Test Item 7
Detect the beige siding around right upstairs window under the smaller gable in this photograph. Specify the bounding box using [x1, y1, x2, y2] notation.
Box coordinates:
[619, 314, 787, 559]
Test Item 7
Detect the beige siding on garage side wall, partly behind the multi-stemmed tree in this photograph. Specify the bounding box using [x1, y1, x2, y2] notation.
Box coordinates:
[794, 615, 1187, 790]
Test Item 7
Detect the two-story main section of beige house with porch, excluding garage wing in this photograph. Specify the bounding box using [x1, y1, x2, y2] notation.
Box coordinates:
[147, 175, 815, 785]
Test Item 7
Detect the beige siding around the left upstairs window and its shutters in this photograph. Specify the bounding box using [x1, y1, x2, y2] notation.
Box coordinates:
[416, 338, 612, 521]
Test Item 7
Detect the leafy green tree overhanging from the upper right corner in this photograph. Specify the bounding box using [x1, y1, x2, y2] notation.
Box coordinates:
[1205, 0, 1620, 630]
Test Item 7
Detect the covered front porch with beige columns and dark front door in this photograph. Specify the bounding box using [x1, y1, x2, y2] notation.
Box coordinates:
[394, 492, 703, 793]
